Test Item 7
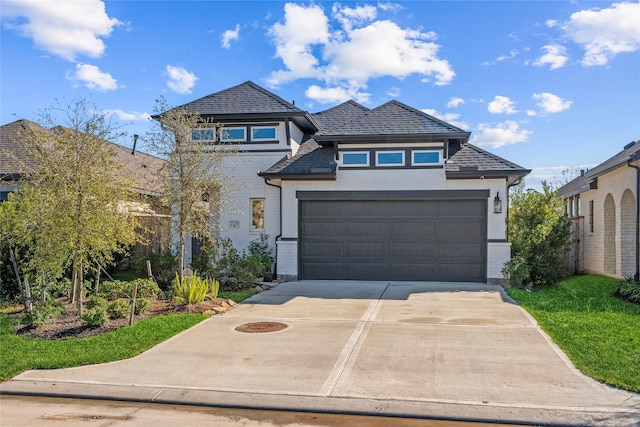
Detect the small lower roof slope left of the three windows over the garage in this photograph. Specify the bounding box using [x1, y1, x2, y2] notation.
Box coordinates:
[260, 139, 337, 179]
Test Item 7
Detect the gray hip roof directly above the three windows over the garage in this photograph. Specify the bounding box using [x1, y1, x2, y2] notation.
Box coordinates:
[318, 100, 468, 140]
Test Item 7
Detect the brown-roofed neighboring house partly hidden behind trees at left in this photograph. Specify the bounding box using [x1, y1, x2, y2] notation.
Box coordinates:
[0, 119, 170, 256]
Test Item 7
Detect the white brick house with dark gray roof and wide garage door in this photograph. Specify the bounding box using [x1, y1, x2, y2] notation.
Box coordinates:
[170, 81, 530, 282]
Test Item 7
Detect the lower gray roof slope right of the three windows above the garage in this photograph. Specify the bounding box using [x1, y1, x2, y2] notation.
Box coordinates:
[445, 143, 531, 184]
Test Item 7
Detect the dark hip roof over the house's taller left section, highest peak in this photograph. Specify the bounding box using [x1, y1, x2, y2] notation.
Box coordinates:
[171, 81, 303, 115]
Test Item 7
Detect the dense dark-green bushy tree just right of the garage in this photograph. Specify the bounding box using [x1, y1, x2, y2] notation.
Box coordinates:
[506, 181, 571, 286]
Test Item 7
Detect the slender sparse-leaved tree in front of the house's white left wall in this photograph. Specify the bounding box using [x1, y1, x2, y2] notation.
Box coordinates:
[143, 98, 235, 282]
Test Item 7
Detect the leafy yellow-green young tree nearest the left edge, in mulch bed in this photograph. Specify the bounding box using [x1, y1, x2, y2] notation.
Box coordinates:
[2, 99, 136, 313]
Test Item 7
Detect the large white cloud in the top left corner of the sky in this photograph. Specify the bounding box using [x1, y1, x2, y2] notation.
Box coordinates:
[0, 0, 122, 61]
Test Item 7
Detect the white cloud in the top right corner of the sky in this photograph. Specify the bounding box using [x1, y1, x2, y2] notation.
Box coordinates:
[561, 2, 640, 66]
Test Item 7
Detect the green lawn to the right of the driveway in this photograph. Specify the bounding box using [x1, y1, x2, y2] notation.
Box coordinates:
[507, 276, 640, 392]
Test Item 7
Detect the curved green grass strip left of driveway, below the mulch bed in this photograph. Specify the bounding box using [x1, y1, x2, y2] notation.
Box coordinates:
[0, 314, 207, 381]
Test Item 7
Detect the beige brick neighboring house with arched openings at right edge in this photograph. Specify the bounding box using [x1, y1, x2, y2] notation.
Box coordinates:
[558, 141, 640, 280]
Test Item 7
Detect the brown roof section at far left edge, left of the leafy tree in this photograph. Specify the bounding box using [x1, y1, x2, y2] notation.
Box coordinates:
[0, 119, 44, 179]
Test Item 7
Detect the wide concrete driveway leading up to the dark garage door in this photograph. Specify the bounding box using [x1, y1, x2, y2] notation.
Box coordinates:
[0, 281, 640, 426]
